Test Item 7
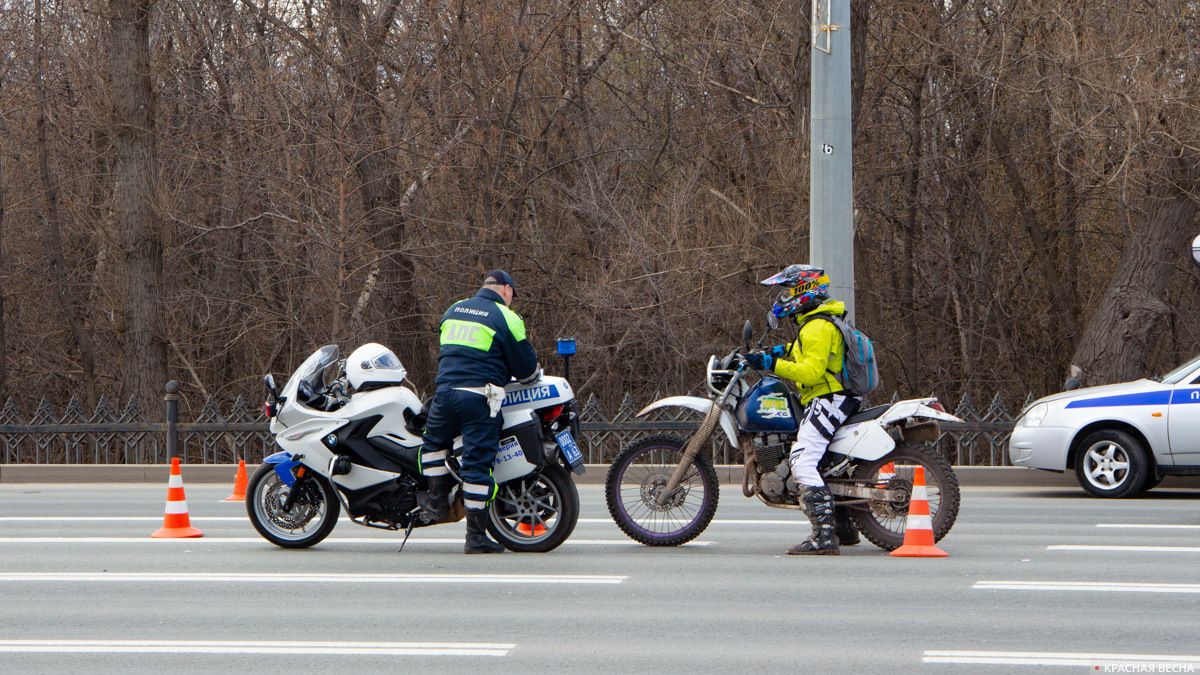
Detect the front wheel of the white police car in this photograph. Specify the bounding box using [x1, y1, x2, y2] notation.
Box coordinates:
[1075, 429, 1150, 498]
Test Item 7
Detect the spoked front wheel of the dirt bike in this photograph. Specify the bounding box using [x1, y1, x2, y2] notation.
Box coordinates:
[605, 436, 720, 546]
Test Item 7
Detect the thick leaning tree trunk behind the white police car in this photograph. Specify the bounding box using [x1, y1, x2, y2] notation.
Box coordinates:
[1072, 157, 1200, 387]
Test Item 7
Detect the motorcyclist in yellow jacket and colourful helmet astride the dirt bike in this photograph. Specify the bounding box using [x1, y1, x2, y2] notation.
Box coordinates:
[749, 264, 862, 555]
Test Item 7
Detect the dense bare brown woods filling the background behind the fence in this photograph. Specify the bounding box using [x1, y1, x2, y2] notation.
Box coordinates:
[0, 0, 1200, 415]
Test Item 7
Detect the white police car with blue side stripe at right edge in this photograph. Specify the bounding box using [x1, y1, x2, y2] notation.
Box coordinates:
[1008, 357, 1200, 497]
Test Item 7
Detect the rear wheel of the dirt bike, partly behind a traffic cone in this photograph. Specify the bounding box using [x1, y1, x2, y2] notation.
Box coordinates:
[850, 443, 962, 551]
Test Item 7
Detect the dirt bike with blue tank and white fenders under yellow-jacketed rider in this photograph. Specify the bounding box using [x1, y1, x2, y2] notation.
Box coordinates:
[605, 321, 962, 551]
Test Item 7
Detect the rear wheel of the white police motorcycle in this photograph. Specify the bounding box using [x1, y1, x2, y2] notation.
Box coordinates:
[487, 464, 580, 554]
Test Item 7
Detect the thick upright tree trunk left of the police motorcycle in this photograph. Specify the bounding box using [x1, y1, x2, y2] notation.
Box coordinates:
[108, 0, 167, 406]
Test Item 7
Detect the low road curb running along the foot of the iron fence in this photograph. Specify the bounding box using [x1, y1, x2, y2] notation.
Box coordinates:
[0, 464, 1200, 488]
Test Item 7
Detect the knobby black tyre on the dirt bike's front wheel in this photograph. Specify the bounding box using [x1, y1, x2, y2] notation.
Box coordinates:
[605, 436, 720, 546]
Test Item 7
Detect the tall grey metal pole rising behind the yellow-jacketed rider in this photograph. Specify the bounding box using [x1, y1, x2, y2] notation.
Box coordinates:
[809, 0, 854, 318]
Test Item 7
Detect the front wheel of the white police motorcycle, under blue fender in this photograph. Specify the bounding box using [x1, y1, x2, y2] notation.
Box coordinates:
[246, 464, 341, 549]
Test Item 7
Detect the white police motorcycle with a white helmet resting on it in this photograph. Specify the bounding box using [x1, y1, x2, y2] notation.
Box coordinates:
[246, 345, 583, 552]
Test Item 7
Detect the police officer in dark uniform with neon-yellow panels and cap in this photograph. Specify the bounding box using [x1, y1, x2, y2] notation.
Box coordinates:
[418, 269, 541, 554]
